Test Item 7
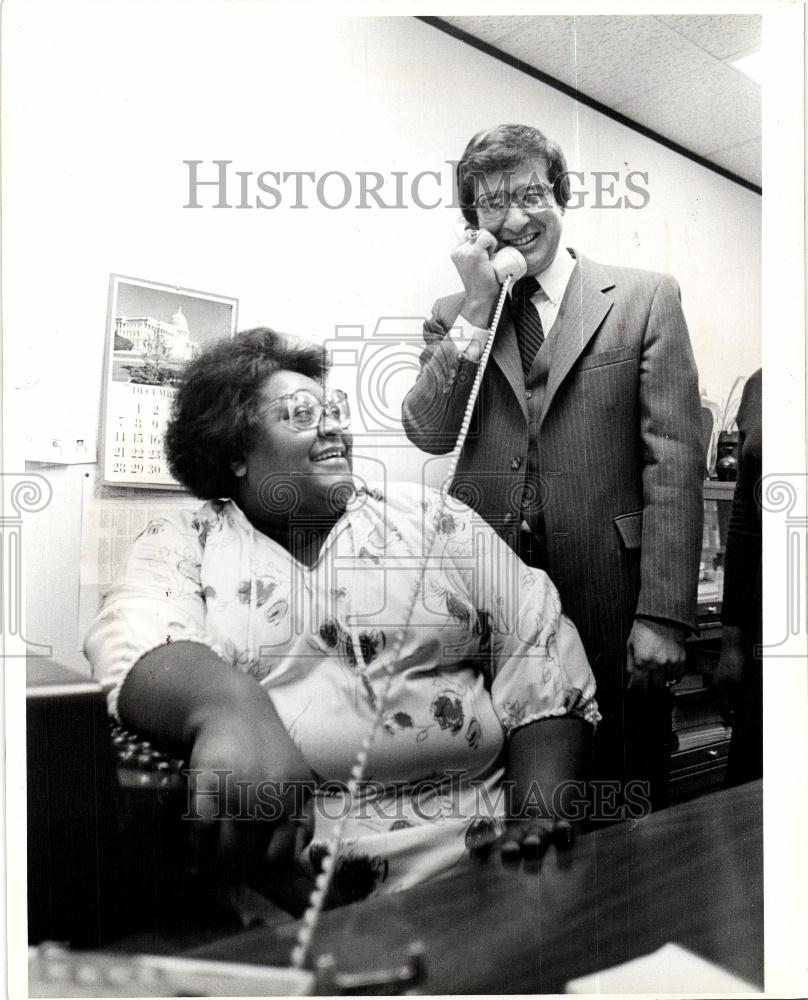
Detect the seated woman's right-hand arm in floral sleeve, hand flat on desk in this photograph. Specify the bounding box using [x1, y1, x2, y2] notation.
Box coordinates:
[438, 500, 600, 856]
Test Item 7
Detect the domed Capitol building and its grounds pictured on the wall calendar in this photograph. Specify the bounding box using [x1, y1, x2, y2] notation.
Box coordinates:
[112, 306, 199, 385]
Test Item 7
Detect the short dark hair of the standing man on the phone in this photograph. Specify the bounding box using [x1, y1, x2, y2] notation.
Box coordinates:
[457, 125, 570, 226]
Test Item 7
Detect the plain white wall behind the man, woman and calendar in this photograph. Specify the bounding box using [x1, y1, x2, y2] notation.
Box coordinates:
[3, 3, 760, 665]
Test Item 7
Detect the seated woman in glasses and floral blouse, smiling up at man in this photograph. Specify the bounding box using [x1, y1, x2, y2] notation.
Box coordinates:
[85, 328, 599, 902]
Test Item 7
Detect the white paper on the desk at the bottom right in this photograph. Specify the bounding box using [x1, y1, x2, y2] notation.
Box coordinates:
[566, 944, 760, 997]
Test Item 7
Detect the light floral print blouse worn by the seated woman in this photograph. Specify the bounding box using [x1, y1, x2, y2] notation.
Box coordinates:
[85, 484, 599, 901]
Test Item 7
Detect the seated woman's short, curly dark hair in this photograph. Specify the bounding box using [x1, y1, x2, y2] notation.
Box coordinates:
[165, 326, 328, 500]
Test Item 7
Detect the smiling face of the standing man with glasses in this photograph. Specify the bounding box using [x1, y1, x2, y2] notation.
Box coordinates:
[476, 159, 564, 275]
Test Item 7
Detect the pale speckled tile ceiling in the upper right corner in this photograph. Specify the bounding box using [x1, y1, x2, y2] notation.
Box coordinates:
[432, 15, 762, 184]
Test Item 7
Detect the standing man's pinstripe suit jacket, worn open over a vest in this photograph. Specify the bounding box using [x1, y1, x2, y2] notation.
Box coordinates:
[403, 251, 704, 712]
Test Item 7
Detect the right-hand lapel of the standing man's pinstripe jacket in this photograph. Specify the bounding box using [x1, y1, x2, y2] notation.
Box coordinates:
[540, 257, 614, 427]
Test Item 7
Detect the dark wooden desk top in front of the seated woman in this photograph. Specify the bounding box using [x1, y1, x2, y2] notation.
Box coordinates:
[191, 782, 763, 994]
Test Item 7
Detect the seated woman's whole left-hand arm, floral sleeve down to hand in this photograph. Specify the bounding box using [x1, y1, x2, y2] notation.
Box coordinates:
[85, 513, 318, 902]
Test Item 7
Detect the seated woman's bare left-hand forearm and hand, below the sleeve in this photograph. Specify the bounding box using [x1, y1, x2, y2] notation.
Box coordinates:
[118, 642, 313, 912]
